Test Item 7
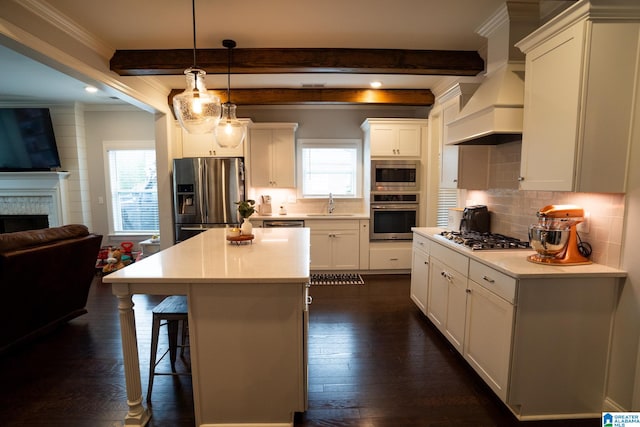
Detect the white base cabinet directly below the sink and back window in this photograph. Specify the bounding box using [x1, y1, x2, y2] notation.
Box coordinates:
[305, 219, 360, 270]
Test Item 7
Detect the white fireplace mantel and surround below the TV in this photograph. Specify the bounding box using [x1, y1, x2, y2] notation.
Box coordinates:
[0, 172, 69, 227]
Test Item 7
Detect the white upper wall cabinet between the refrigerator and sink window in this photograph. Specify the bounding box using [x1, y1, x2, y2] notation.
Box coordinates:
[249, 123, 298, 188]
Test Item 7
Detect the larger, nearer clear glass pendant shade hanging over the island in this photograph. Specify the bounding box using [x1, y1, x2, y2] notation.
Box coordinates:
[173, 68, 221, 134]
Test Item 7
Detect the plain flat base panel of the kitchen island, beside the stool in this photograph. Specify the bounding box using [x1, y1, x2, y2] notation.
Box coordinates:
[188, 283, 306, 426]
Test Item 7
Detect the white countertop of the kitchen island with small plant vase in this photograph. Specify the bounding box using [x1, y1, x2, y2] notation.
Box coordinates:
[102, 228, 310, 283]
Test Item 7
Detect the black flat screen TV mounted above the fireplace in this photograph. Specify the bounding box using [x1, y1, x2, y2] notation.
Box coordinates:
[0, 108, 61, 172]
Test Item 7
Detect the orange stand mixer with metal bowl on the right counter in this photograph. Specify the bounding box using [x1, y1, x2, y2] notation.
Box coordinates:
[527, 205, 591, 265]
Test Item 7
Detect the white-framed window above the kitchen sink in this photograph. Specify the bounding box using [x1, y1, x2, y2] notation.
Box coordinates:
[298, 139, 362, 198]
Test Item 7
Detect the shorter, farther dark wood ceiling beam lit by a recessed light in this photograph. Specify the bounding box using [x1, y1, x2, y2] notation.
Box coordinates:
[169, 88, 434, 107]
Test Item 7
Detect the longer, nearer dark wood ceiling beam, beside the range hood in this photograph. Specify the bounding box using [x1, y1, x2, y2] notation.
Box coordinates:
[110, 48, 484, 76]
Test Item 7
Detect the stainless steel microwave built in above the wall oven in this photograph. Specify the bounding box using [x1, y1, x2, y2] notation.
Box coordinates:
[371, 160, 420, 191]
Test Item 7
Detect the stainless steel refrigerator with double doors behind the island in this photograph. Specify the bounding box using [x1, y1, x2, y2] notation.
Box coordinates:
[173, 157, 245, 243]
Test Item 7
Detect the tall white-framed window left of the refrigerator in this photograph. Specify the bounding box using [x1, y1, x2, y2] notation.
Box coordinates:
[103, 141, 160, 234]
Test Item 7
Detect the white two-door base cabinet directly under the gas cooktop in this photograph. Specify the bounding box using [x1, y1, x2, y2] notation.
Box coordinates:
[427, 245, 469, 353]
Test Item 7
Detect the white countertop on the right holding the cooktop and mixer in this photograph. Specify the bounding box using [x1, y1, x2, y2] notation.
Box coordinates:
[413, 227, 627, 279]
